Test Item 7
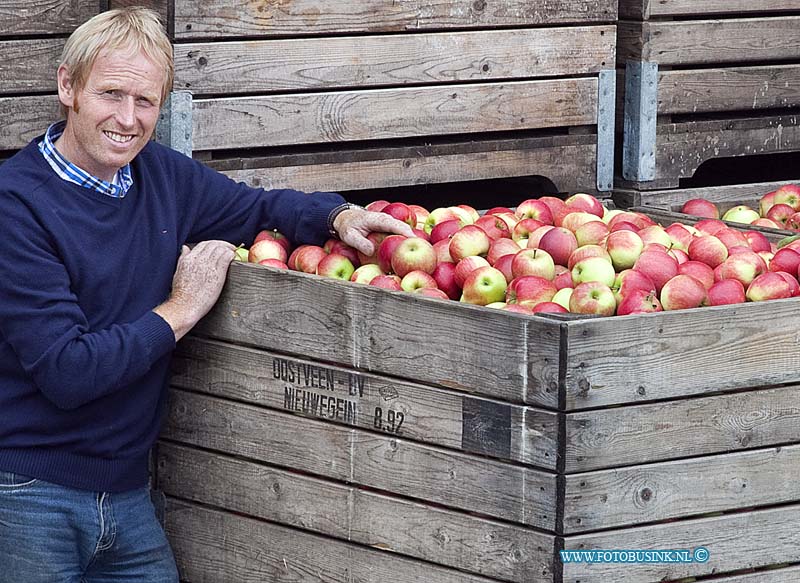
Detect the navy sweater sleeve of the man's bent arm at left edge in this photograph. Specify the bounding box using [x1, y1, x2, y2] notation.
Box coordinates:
[0, 193, 175, 409]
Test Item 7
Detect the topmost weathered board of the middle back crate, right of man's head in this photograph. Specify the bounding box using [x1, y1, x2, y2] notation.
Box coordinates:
[174, 0, 617, 39]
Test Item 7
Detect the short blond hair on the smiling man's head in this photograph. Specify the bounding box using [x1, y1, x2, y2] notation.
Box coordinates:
[59, 7, 175, 115]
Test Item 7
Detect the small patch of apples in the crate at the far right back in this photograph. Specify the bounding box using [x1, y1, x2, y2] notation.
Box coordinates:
[681, 184, 800, 231]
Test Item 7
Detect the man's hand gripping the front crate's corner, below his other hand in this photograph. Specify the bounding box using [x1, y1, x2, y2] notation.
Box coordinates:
[153, 241, 235, 341]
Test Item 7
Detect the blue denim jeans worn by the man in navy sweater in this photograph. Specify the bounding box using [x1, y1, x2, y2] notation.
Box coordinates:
[0, 471, 178, 583]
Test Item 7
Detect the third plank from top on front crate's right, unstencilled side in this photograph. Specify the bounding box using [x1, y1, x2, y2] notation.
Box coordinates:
[564, 442, 800, 534]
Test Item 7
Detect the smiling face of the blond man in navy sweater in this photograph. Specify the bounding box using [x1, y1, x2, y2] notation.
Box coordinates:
[56, 51, 164, 182]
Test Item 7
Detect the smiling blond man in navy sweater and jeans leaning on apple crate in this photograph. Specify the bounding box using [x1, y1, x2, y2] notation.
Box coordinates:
[0, 9, 411, 583]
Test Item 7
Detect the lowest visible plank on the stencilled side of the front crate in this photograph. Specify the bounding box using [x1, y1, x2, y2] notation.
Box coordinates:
[165, 499, 506, 583]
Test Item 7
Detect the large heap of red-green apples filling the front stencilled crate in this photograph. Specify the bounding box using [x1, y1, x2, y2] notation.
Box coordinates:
[239, 193, 800, 316]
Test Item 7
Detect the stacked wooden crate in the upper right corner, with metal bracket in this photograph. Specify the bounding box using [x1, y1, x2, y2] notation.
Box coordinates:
[617, 0, 800, 190]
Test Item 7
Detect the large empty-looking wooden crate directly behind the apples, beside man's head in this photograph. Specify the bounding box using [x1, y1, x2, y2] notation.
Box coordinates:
[172, 0, 617, 192]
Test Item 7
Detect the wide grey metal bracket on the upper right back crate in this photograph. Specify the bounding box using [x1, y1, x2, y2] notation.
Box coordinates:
[622, 61, 658, 182]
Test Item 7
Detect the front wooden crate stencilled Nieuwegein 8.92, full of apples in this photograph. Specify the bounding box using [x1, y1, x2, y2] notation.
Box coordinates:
[156, 264, 800, 583]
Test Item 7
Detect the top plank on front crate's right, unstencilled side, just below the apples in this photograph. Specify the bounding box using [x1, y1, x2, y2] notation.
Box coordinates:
[564, 299, 800, 410]
